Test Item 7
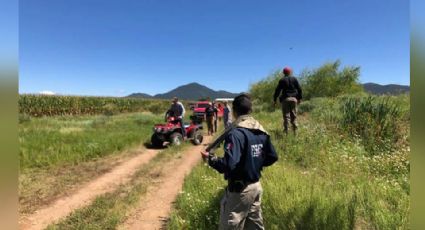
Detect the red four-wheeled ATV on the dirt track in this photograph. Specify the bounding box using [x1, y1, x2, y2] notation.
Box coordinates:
[151, 113, 204, 147]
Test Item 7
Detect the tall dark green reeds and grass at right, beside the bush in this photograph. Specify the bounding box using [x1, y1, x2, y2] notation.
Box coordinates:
[306, 95, 410, 155]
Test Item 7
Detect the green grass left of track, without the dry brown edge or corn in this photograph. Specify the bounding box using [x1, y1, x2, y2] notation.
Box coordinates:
[19, 113, 161, 171]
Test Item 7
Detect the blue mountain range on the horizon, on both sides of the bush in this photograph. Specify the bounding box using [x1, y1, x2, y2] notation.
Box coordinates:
[127, 82, 410, 100]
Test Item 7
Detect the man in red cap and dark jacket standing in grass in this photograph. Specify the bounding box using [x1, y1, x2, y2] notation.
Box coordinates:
[273, 67, 303, 134]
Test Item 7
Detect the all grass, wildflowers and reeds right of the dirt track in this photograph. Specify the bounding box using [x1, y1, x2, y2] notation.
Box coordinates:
[169, 95, 410, 229]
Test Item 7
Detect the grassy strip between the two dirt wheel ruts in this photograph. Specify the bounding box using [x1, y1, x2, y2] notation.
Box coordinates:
[47, 144, 189, 230]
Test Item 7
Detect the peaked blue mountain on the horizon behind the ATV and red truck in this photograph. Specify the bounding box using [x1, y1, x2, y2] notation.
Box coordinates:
[127, 82, 238, 100]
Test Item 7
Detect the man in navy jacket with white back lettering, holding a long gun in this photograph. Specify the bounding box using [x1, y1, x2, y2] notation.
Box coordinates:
[201, 94, 278, 229]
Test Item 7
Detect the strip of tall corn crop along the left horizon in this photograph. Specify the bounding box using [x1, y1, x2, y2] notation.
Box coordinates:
[19, 95, 170, 117]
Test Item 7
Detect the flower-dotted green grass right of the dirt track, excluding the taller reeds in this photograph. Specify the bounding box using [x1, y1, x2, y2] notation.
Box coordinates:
[168, 105, 410, 229]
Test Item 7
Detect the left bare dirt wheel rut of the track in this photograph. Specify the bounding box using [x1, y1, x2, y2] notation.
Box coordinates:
[19, 149, 160, 230]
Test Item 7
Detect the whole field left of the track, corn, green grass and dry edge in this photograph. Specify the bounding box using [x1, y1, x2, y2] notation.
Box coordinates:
[18, 95, 174, 213]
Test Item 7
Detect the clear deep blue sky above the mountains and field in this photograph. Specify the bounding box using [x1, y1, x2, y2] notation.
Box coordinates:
[19, 0, 410, 96]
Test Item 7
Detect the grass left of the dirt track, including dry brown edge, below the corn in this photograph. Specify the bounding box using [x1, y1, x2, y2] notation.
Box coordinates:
[19, 113, 161, 213]
